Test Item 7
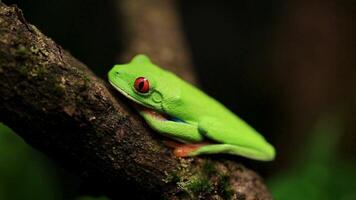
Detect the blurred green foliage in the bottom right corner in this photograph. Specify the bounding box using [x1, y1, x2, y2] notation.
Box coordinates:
[268, 117, 356, 200]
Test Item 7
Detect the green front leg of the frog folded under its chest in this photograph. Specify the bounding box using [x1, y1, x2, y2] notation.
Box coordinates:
[140, 110, 203, 142]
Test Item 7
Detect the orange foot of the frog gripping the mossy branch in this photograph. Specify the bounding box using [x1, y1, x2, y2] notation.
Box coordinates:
[164, 141, 210, 157]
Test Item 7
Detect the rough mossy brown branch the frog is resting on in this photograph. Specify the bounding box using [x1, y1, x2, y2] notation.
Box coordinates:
[0, 4, 271, 199]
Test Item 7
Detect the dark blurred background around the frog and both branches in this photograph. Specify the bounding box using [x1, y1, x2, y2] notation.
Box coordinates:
[0, 0, 356, 200]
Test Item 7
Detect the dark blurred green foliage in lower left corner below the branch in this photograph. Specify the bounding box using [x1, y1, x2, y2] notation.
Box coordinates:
[0, 124, 61, 200]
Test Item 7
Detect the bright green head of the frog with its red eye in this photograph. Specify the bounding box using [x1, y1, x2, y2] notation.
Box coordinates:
[108, 55, 176, 112]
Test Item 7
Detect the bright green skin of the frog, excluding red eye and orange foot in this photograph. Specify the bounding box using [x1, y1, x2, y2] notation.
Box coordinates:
[108, 55, 275, 161]
